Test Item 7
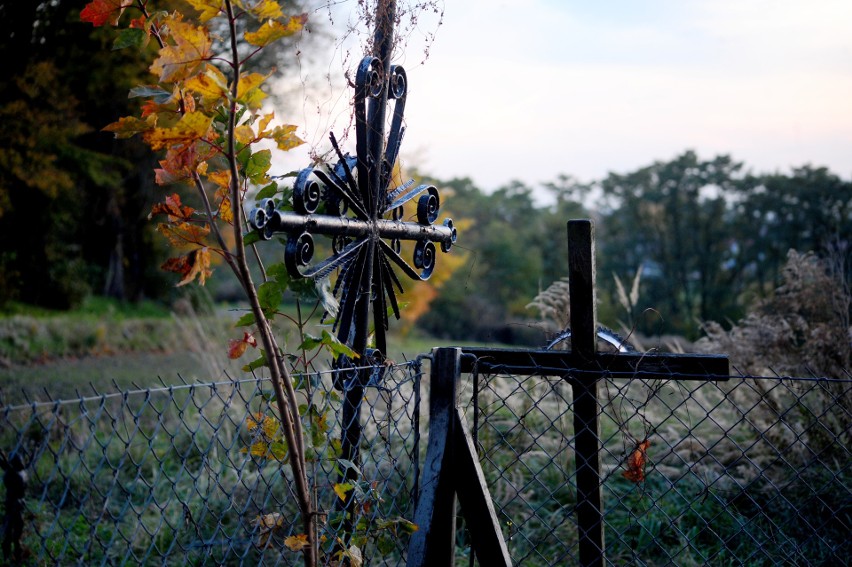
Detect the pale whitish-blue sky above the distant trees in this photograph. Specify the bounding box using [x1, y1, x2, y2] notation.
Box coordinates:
[276, 0, 852, 199]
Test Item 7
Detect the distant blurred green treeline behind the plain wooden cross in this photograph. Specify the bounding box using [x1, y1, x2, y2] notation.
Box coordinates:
[419, 151, 852, 342]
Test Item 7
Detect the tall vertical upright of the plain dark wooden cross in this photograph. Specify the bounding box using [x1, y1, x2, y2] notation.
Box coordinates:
[568, 220, 604, 567]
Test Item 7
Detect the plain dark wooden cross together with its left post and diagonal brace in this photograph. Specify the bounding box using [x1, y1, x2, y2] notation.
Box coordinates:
[408, 220, 729, 566]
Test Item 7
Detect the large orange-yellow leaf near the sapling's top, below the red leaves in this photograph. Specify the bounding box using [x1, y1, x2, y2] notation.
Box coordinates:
[151, 17, 213, 83]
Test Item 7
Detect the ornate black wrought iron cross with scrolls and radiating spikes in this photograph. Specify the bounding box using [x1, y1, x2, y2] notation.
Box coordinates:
[249, 1, 456, 355]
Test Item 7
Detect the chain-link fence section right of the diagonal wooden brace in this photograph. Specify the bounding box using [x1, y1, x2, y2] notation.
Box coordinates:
[467, 366, 852, 566]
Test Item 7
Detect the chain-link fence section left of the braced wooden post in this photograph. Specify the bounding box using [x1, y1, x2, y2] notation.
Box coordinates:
[0, 362, 421, 565]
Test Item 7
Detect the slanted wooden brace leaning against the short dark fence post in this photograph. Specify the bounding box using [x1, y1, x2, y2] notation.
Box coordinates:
[453, 408, 512, 567]
